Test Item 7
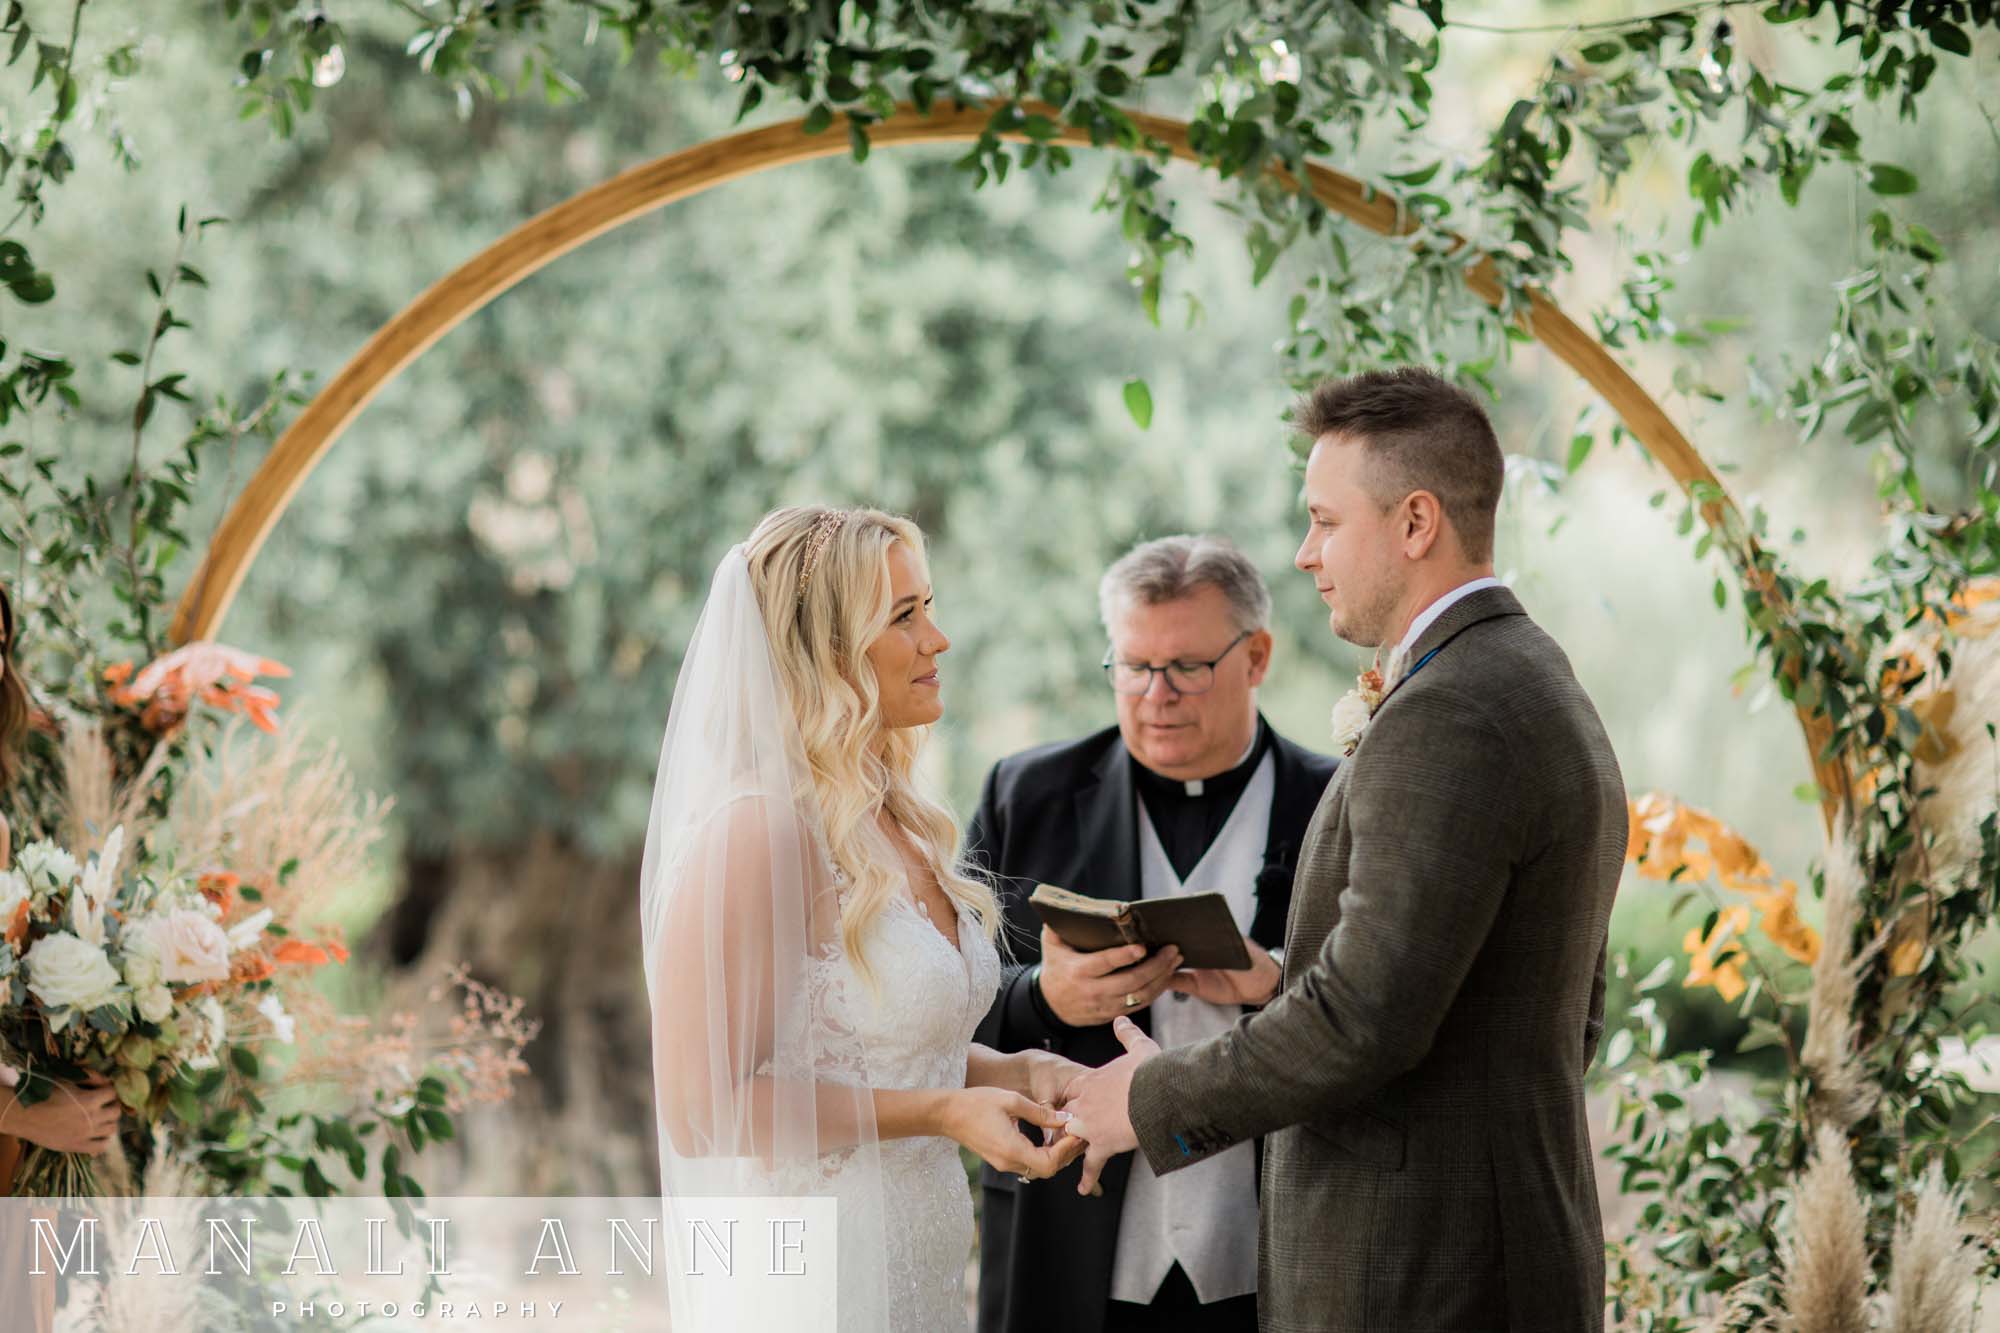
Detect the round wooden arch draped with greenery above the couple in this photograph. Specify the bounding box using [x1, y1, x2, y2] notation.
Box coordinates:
[170, 106, 1846, 799]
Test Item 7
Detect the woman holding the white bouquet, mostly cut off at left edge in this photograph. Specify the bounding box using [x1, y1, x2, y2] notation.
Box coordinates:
[0, 586, 118, 1333]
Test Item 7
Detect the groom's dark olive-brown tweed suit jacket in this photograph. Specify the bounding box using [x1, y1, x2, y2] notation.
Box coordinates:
[1130, 588, 1628, 1333]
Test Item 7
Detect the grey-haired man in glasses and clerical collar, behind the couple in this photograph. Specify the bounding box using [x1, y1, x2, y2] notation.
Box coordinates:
[966, 536, 1336, 1333]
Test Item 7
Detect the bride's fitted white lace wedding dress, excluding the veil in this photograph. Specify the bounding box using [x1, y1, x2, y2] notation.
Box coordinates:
[810, 856, 1000, 1333]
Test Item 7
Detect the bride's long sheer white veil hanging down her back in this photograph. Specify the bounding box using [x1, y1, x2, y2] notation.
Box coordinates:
[640, 546, 890, 1329]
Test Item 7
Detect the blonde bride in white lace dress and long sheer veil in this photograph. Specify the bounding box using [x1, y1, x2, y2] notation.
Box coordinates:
[640, 506, 1082, 1333]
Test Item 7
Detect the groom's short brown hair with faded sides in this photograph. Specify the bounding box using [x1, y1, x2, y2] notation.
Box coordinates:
[1290, 366, 1506, 562]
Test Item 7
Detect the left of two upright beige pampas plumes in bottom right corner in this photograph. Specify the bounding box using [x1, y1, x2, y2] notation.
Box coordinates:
[1784, 1125, 1868, 1333]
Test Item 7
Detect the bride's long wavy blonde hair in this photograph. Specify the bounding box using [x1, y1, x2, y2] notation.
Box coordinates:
[744, 504, 1000, 987]
